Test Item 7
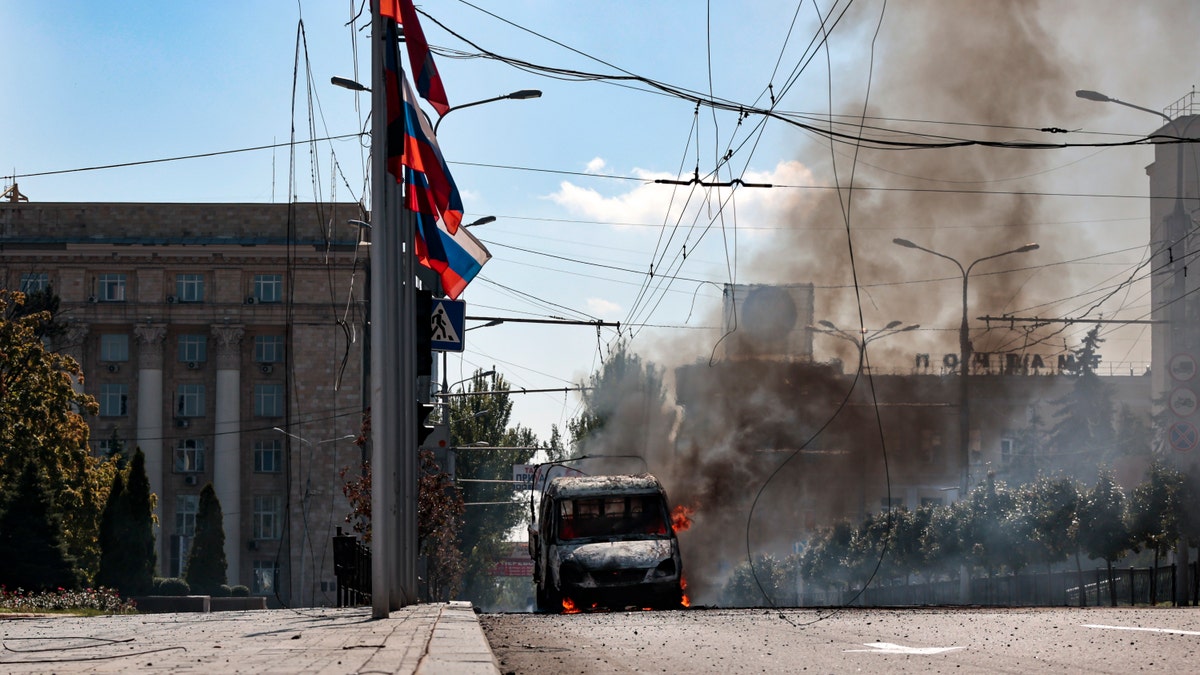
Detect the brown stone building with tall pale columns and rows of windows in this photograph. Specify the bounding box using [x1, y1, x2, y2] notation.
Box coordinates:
[0, 202, 367, 607]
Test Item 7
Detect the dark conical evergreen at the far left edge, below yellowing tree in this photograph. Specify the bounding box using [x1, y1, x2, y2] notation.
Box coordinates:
[0, 461, 82, 591]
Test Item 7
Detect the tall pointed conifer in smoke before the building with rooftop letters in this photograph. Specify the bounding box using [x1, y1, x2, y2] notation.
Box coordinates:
[1046, 325, 1116, 476]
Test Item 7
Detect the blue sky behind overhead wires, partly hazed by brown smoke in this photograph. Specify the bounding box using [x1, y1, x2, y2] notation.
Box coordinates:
[0, 0, 1200, 438]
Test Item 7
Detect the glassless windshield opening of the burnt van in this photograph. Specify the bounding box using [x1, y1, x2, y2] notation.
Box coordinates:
[558, 495, 670, 540]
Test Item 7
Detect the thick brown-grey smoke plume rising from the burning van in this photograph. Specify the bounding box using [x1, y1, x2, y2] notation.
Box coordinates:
[578, 0, 1187, 603]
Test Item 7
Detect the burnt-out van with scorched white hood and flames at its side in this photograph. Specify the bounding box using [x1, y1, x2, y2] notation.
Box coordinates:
[529, 473, 684, 611]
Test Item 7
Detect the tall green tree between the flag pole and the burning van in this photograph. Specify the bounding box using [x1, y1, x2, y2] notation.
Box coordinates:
[448, 370, 538, 608]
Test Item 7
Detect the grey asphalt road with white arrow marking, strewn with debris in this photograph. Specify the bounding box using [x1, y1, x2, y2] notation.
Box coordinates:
[479, 608, 1200, 675]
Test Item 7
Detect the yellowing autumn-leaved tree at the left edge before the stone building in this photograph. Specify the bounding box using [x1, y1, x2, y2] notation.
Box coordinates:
[0, 289, 114, 577]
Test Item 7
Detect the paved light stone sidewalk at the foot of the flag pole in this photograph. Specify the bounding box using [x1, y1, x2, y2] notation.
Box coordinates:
[0, 602, 499, 675]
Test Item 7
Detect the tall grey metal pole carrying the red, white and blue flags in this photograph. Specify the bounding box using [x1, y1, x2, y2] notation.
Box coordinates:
[370, 0, 416, 619]
